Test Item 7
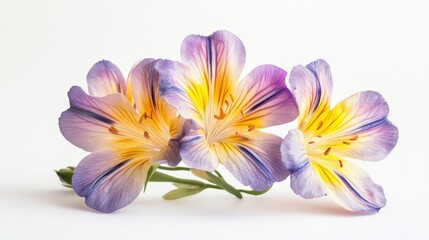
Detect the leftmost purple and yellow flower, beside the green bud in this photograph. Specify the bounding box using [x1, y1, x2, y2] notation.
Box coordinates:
[59, 59, 184, 212]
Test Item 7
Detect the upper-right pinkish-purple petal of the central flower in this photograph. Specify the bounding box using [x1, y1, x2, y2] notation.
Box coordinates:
[229, 65, 298, 128]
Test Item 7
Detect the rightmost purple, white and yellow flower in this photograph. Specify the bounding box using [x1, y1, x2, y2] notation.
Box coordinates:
[281, 60, 398, 213]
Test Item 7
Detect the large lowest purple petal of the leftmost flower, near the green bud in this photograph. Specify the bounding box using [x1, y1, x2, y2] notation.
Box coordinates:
[72, 151, 150, 213]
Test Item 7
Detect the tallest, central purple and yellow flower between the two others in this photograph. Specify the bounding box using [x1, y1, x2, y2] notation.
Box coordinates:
[155, 31, 298, 190]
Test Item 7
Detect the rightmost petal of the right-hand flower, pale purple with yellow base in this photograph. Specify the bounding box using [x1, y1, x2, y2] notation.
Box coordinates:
[315, 91, 398, 161]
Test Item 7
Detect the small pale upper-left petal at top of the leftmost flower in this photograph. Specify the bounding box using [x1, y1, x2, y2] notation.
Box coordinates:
[87, 60, 126, 97]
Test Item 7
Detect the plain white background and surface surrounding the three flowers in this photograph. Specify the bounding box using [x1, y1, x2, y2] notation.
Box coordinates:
[0, 0, 429, 239]
